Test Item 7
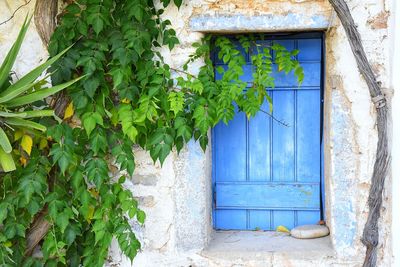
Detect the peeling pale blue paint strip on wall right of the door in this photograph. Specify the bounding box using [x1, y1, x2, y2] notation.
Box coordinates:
[330, 85, 357, 255]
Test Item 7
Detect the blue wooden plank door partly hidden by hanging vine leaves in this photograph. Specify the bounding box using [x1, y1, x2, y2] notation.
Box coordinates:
[212, 34, 322, 230]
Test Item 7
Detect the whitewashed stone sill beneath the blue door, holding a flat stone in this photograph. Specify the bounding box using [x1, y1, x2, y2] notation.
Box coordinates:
[201, 231, 336, 261]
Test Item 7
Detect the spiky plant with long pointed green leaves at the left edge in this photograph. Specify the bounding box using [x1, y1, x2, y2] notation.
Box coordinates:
[0, 17, 80, 172]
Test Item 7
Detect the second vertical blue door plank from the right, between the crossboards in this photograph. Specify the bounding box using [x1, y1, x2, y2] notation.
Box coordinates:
[272, 90, 295, 181]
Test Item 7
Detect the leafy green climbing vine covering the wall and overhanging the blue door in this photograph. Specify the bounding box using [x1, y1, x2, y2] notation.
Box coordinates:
[0, 0, 304, 266]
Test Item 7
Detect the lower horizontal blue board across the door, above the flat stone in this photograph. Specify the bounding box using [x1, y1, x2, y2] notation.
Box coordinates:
[216, 182, 319, 210]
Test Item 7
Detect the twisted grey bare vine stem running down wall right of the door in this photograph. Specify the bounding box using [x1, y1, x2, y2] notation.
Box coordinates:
[329, 0, 390, 267]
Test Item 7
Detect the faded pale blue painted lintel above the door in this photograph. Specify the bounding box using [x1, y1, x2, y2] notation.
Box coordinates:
[190, 13, 329, 32]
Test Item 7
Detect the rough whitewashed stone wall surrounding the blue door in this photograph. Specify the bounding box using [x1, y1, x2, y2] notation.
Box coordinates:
[0, 0, 395, 267]
